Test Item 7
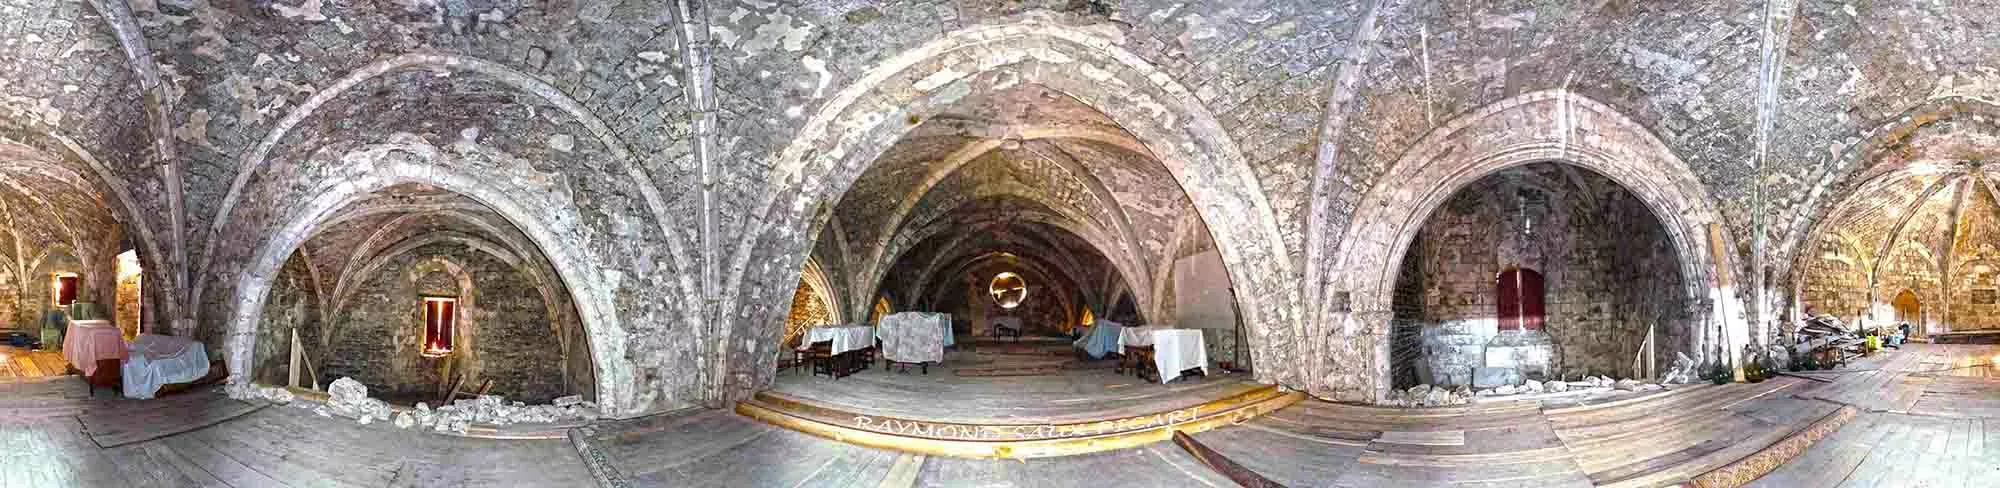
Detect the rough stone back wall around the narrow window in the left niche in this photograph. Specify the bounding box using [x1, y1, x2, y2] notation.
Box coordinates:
[324, 244, 570, 404]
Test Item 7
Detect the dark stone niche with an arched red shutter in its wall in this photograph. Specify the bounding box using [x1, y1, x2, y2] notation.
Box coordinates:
[1390, 162, 1692, 388]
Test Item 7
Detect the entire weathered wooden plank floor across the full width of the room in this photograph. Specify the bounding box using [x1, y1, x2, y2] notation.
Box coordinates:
[11, 346, 2000, 488]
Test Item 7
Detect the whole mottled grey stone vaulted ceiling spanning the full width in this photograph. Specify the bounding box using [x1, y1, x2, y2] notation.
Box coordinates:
[0, 0, 2000, 412]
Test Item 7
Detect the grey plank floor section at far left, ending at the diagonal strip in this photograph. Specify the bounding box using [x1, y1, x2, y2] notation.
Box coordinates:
[0, 380, 590, 488]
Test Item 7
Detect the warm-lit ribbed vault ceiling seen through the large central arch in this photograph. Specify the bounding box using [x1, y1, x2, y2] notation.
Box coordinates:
[832, 84, 1206, 320]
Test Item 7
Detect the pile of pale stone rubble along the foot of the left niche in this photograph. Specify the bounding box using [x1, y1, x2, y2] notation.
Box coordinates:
[230, 378, 598, 434]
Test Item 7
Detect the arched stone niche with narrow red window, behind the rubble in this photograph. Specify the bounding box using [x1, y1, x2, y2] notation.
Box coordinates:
[252, 184, 598, 406]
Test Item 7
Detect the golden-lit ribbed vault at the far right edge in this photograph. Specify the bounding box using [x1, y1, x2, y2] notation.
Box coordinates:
[1800, 120, 2000, 334]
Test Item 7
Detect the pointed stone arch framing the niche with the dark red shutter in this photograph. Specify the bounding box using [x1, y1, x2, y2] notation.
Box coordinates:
[1310, 90, 1748, 402]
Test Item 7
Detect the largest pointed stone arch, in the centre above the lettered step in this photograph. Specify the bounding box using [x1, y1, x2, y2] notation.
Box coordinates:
[736, 18, 1304, 394]
